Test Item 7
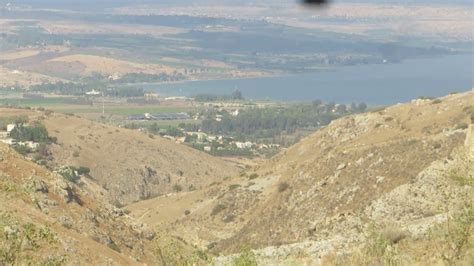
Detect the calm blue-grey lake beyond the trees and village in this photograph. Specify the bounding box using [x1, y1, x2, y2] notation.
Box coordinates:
[145, 54, 474, 104]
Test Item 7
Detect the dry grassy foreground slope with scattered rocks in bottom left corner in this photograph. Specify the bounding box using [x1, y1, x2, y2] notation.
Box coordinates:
[0, 144, 156, 265]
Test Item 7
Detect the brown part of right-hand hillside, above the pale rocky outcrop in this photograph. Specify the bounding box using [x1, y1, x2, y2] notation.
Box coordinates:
[129, 92, 474, 254]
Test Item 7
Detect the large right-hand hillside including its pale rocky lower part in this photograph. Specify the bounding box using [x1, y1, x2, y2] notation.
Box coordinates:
[129, 92, 474, 263]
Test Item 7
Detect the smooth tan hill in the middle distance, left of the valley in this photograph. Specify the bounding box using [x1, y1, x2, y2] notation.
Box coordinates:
[42, 114, 237, 204]
